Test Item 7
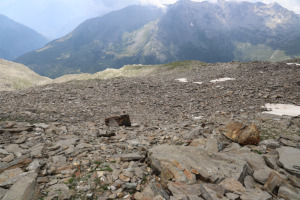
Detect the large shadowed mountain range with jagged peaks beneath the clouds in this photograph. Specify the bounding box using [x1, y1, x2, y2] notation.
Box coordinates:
[16, 0, 300, 77]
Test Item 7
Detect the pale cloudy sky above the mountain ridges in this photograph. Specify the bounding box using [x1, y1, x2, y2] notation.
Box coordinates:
[0, 0, 300, 39]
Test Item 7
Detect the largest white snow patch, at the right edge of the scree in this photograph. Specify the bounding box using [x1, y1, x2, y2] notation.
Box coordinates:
[263, 103, 300, 117]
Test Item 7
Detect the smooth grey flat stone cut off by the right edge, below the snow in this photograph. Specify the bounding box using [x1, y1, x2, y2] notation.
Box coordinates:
[276, 147, 300, 177]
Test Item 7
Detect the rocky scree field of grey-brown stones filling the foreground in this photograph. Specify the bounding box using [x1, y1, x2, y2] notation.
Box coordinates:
[0, 60, 300, 200]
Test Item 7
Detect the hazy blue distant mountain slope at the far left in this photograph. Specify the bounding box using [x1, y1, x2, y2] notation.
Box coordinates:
[0, 14, 48, 60]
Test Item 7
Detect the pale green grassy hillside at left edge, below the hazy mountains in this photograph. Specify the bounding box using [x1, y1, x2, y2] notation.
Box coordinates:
[0, 59, 52, 91]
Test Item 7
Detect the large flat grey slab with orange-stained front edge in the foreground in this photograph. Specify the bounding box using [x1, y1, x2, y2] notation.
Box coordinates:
[148, 145, 249, 183]
